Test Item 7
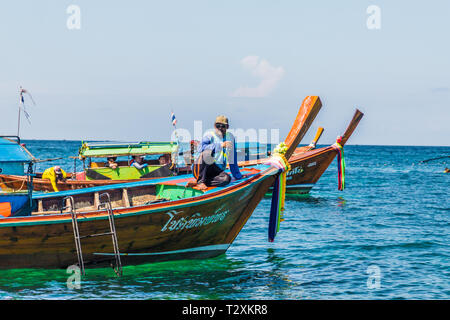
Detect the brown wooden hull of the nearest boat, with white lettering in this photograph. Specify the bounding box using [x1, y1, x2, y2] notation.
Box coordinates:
[0, 170, 275, 269]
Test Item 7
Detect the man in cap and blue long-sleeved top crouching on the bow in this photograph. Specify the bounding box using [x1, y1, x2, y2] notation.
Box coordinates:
[193, 116, 243, 190]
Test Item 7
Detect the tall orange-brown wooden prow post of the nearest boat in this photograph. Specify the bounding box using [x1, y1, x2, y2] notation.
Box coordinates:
[284, 96, 322, 159]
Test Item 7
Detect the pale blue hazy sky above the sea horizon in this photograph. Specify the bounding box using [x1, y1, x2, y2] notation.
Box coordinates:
[0, 0, 450, 146]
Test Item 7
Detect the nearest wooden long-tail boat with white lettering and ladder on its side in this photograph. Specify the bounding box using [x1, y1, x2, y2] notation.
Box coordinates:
[0, 96, 321, 269]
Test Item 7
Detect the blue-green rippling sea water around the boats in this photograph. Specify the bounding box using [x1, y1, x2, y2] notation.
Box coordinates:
[0, 140, 450, 299]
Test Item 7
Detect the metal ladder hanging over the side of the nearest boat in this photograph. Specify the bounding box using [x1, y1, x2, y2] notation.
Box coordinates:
[61, 193, 122, 277]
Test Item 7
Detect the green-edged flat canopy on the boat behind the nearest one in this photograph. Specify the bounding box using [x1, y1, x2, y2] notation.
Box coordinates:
[78, 141, 178, 159]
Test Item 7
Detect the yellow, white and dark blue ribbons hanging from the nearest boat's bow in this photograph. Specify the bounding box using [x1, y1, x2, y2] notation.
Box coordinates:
[266, 142, 291, 242]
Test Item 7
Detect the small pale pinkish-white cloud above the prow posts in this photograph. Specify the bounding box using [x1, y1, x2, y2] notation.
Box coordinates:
[231, 56, 284, 97]
